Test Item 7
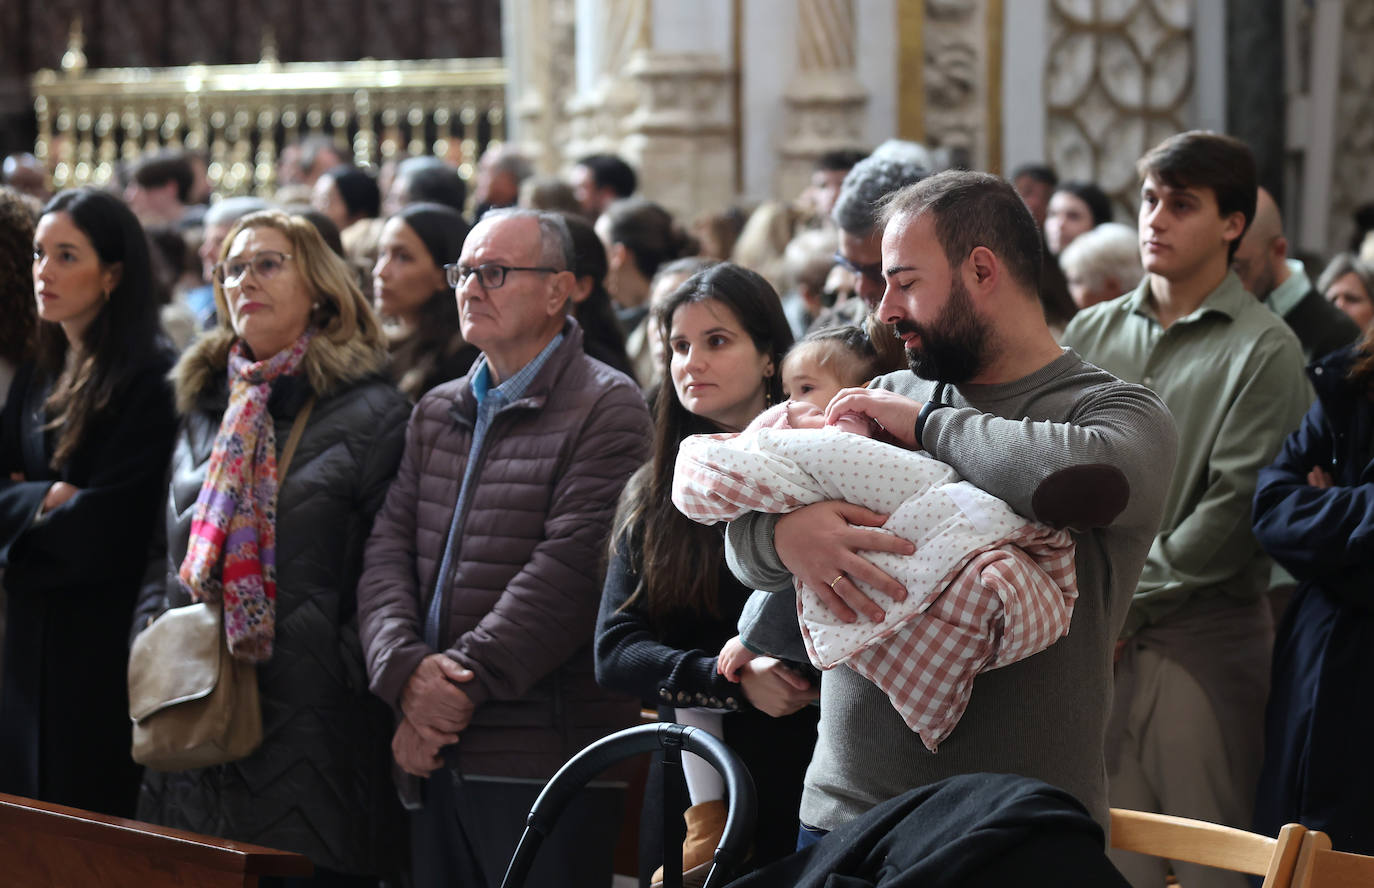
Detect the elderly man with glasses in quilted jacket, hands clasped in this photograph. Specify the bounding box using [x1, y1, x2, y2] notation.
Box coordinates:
[359, 210, 650, 888]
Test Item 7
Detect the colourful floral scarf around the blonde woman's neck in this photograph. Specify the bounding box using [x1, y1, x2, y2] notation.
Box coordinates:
[180, 330, 313, 663]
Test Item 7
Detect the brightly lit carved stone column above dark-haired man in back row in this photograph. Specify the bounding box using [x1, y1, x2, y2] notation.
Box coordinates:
[563, 0, 651, 162]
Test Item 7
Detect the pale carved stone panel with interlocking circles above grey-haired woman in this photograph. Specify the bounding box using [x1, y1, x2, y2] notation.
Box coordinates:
[1046, 0, 1194, 216]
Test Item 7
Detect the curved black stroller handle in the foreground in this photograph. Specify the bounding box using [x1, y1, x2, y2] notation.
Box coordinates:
[502, 723, 758, 888]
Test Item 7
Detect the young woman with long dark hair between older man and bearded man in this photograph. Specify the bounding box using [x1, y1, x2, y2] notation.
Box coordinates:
[596, 263, 816, 883]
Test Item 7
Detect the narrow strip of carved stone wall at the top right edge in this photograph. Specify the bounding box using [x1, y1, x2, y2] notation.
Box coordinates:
[1327, 1, 1374, 252]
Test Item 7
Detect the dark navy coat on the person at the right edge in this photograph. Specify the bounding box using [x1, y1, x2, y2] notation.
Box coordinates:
[1254, 349, 1374, 854]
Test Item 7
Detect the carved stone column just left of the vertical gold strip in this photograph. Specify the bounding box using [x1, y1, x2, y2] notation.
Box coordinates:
[776, 0, 868, 199]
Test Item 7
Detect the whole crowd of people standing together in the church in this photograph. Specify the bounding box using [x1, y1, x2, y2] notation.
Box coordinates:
[0, 123, 1374, 888]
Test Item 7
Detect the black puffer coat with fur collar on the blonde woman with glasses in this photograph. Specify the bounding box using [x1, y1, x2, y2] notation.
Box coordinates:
[135, 325, 409, 874]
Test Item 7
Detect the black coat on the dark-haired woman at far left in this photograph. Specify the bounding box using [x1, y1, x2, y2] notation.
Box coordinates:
[0, 352, 176, 817]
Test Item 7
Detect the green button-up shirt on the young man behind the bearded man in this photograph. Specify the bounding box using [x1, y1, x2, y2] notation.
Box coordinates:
[1061, 272, 1312, 636]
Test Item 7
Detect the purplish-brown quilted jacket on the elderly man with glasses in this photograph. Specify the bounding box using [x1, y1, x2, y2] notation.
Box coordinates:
[359, 320, 650, 779]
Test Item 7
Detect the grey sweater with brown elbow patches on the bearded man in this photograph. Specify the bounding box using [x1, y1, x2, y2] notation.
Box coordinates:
[727, 349, 1176, 829]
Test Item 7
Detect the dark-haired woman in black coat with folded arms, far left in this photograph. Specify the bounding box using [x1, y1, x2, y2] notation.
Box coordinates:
[0, 188, 176, 817]
